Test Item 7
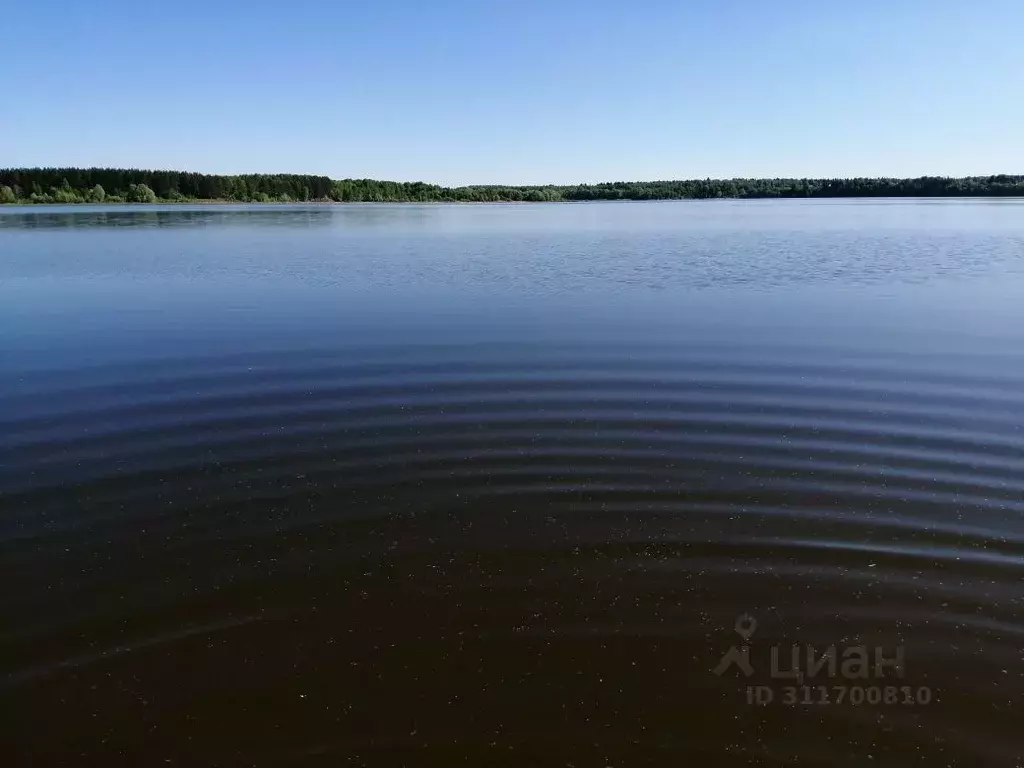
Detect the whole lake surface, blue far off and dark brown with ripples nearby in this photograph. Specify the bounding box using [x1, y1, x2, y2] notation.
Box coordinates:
[0, 200, 1024, 766]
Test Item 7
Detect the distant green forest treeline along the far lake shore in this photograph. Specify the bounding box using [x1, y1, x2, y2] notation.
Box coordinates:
[0, 168, 1024, 203]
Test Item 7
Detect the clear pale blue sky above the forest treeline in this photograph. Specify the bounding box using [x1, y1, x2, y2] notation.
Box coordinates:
[0, 0, 1024, 183]
